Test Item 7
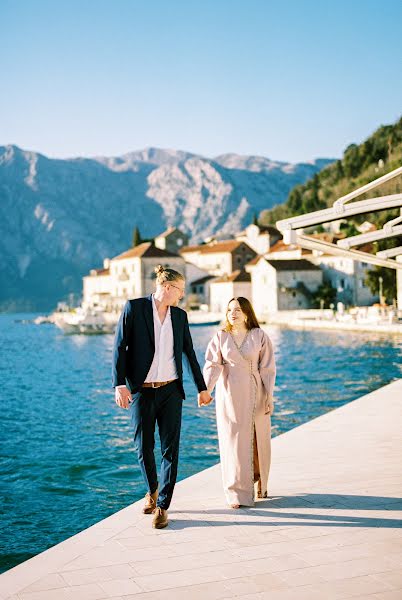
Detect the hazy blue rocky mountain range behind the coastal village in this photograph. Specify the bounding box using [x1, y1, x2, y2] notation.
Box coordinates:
[0, 145, 333, 310]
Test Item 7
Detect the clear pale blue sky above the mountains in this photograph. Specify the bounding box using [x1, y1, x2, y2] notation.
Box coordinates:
[0, 0, 402, 162]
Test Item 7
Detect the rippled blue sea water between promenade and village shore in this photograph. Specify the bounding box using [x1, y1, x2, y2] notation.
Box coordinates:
[0, 315, 402, 570]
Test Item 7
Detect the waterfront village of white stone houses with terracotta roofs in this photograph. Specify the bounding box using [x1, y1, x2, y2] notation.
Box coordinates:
[78, 222, 390, 322]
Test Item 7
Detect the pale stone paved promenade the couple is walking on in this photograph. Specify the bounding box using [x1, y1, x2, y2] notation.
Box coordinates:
[0, 379, 402, 600]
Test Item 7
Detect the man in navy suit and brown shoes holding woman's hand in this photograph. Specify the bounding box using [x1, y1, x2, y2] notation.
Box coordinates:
[113, 266, 211, 529]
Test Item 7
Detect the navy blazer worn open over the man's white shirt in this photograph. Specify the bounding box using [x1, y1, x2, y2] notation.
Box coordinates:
[112, 296, 207, 398]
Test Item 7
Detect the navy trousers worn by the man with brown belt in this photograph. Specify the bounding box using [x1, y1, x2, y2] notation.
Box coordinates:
[130, 381, 183, 509]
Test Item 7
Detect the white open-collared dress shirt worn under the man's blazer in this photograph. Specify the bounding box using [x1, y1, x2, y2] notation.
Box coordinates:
[145, 294, 178, 383]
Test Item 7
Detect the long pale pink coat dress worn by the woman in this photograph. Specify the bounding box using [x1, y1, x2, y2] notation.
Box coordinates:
[204, 328, 276, 506]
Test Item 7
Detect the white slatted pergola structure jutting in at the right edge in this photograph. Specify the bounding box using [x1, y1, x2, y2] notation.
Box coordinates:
[276, 167, 402, 310]
